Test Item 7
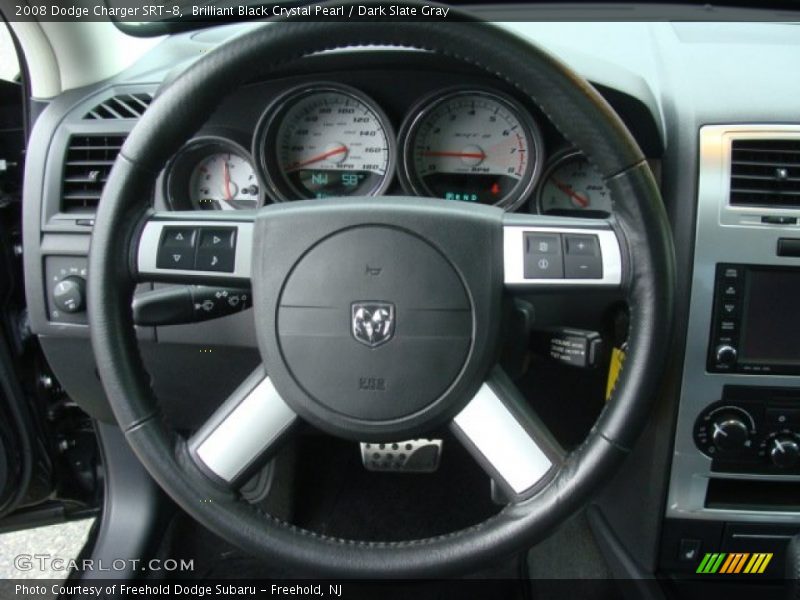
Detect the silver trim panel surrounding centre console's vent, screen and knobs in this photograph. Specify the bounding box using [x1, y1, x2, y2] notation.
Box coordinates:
[666, 124, 800, 522]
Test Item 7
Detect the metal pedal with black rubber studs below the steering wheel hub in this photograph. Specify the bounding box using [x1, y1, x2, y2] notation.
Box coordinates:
[361, 439, 442, 473]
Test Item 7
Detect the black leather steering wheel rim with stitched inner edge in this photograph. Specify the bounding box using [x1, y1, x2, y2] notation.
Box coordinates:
[88, 12, 674, 577]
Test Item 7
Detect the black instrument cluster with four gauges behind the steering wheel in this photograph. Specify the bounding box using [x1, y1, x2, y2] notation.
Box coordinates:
[144, 52, 658, 218]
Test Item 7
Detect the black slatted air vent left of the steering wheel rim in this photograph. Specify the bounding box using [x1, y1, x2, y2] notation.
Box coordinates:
[61, 135, 125, 213]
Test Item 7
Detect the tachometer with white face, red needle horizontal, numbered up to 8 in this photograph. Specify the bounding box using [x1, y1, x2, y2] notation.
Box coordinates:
[401, 90, 542, 210]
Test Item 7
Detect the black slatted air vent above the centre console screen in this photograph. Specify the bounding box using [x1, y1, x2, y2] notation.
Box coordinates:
[730, 139, 800, 208]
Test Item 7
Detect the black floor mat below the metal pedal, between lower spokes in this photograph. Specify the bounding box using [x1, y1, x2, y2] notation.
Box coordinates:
[295, 433, 500, 541]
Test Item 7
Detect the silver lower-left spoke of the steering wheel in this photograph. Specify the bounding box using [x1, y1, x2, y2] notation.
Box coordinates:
[188, 365, 297, 488]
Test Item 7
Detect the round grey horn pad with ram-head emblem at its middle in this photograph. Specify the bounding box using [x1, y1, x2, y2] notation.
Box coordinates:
[277, 226, 472, 421]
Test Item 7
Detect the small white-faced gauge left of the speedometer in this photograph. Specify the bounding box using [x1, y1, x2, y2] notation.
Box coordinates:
[166, 137, 263, 210]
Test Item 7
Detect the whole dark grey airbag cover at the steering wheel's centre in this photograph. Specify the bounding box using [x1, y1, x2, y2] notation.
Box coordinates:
[253, 199, 502, 439]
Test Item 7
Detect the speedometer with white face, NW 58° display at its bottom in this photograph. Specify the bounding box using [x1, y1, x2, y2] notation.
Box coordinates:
[254, 84, 395, 200]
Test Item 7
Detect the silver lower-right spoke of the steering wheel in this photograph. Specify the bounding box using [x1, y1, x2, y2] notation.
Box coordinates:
[451, 368, 565, 502]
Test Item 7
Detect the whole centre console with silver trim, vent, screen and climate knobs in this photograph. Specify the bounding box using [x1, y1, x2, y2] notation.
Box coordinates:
[660, 125, 800, 577]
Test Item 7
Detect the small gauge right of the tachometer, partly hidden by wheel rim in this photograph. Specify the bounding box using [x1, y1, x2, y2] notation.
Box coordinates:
[536, 151, 612, 216]
